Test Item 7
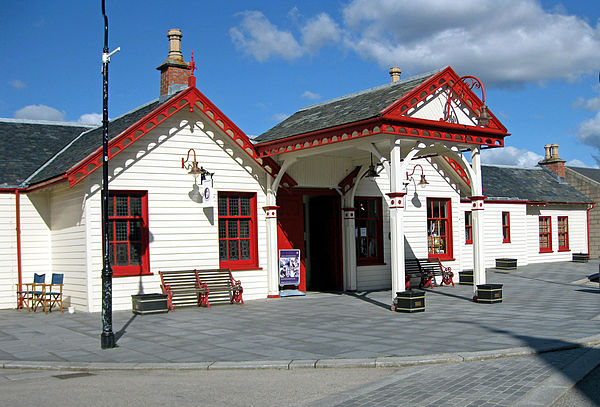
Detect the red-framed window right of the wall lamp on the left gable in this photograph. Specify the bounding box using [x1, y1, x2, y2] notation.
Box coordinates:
[218, 192, 258, 269]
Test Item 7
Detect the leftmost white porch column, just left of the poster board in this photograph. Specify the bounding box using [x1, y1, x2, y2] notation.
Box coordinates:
[263, 174, 279, 298]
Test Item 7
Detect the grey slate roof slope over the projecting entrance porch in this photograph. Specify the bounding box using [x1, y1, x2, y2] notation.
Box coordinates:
[253, 70, 441, 143]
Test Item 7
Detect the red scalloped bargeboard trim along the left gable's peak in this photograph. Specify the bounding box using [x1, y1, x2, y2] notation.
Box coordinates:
[66, 87, 297, 186]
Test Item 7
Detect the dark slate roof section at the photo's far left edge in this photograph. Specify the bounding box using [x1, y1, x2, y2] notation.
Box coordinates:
[0, 119, 90, 188]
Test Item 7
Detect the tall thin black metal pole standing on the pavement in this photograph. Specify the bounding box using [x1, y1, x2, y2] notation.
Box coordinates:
[100, 0, 115, 349]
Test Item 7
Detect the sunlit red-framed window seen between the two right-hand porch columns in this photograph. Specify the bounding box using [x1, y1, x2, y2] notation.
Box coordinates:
[427, 198, 452, 260]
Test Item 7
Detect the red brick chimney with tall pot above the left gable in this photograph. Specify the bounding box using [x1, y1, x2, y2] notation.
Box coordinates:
[156, 28, 190, 97]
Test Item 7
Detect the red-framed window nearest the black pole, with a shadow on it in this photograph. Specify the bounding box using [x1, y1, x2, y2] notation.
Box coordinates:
[108, 191, 150, 277]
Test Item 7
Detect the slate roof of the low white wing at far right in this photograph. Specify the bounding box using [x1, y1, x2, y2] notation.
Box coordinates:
[481, 165, 592, 203]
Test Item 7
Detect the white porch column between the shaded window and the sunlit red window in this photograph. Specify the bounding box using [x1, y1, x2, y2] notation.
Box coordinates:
[387, 137, 406, 301]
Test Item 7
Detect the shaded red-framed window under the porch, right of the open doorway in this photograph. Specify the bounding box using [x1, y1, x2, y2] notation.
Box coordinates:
[354, 197, 383, 265]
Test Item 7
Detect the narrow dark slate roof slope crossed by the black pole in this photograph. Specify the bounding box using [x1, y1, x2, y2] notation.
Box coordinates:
[30, 99, 162, 184]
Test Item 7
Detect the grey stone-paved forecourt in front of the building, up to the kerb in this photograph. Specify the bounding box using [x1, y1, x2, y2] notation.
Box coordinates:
[0, 260, 600, 369]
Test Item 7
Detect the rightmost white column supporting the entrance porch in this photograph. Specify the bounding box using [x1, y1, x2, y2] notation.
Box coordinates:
[471, 147, 486, 294]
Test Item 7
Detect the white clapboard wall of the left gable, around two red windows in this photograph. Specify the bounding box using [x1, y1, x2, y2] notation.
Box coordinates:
[81, 111, 267, 311]
